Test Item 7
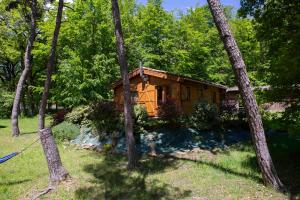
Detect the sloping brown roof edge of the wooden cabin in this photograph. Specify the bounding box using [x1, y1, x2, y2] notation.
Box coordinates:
[112, 67, 227, 90]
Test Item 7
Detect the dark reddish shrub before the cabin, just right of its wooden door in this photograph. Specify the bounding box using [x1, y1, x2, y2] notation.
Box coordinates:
[158, 100, 182, 125]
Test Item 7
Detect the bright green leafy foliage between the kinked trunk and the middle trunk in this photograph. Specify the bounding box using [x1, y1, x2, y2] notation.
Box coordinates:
[49, 0, 119, 107]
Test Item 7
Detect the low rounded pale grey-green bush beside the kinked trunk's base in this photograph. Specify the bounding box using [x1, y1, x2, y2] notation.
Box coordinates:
[52, 122, 80, 142]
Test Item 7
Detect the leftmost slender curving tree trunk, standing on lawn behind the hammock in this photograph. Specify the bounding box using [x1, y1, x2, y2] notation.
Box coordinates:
[11, 0, 37, 137]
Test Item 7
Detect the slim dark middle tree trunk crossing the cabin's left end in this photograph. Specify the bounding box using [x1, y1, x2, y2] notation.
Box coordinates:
[111, 0, 138, 169]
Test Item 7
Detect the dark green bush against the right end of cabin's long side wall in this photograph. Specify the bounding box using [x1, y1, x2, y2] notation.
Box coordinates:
[189, 102, 219, 131]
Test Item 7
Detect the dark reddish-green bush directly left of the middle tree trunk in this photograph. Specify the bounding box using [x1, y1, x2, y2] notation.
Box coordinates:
[88, 101, 123, 139]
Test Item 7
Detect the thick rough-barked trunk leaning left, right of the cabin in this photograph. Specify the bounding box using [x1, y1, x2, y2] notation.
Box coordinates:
[207, 0, 284, 190]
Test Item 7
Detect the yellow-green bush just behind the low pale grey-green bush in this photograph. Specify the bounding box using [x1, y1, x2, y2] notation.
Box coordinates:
[65, 106, 91, 125]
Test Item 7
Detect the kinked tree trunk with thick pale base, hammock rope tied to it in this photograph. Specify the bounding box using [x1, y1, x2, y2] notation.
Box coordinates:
[39, 0, 69, 185]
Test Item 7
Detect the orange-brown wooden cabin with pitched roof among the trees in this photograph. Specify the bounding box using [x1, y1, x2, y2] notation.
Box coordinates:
[113, 67, 227, 117]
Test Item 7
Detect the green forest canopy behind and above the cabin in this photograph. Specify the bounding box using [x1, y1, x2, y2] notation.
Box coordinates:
[0, 0, 299, 117]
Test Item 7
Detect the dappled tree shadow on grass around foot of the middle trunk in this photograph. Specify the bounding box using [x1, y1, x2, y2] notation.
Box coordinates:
[76, 156, 191, 200]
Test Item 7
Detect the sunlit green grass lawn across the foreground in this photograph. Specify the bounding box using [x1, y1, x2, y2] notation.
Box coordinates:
[0, 118, 300, 200]
